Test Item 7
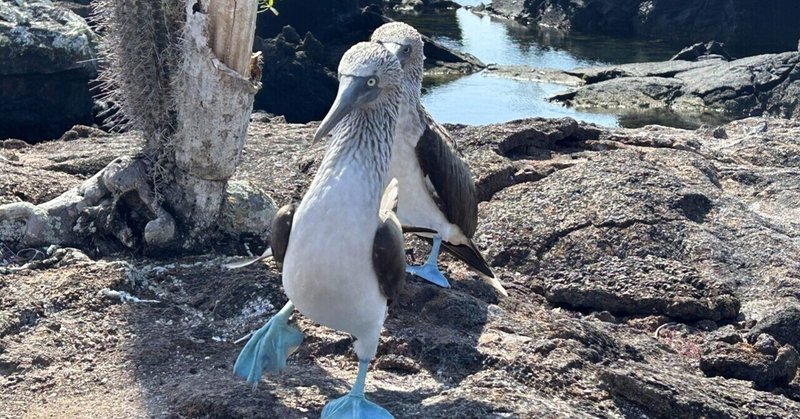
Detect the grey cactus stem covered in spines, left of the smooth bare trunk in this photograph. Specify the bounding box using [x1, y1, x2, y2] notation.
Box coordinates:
[94, 0, 186, 204]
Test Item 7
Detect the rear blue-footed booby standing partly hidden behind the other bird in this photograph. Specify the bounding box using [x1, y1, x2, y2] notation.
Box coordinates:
[371, 22, 508, 295]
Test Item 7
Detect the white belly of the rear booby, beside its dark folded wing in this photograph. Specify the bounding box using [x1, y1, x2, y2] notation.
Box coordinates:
[389, 112, 466, 244]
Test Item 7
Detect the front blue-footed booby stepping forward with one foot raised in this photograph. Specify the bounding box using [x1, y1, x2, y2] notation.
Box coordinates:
[234, 42, 405, 419]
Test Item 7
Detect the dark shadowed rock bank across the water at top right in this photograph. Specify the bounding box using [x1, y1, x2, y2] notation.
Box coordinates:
[487, 0, 800, 51]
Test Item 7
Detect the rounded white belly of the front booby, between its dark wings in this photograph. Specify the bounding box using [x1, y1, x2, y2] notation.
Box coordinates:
[283, 169, 386, 340]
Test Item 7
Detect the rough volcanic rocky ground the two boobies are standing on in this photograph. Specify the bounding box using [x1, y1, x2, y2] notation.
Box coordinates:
[0, 115, 800, 418]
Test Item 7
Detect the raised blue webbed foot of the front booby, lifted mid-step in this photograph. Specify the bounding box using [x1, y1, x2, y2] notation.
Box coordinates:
[233, 301, 303, 385]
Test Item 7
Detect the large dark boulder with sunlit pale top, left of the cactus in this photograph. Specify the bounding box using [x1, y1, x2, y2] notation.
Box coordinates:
[0, 0, 97, 141]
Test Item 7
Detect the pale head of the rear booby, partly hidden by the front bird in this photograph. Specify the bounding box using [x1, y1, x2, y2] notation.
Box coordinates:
[370, 22, 425, 77]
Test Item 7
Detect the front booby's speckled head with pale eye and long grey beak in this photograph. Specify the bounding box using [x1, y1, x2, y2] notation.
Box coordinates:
[314, 42, 403, 142]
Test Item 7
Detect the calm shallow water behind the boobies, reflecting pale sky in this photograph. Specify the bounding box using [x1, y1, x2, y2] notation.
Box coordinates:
[395, 5, 713, 127]
